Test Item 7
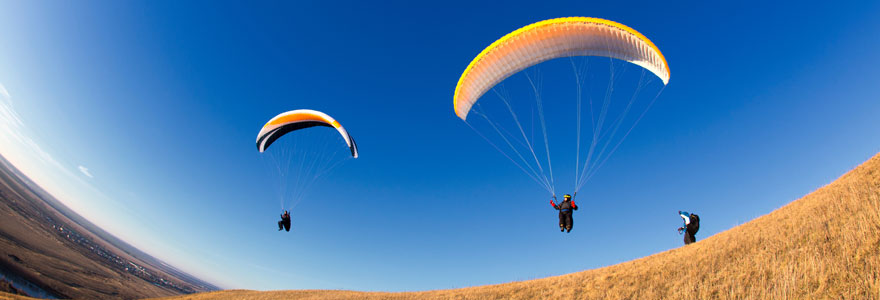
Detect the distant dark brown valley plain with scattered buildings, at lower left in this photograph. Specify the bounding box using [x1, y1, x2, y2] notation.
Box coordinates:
[0, 157, 215, 299]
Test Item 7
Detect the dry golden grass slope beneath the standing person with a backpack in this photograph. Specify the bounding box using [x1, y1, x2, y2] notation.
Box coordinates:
[3, 154, 880, 299]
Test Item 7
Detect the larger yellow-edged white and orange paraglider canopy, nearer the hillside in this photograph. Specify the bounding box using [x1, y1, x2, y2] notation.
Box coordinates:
[453, 17, 669, 120]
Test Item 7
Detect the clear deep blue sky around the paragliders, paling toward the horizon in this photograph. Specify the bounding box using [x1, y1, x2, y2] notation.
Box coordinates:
[0, 1, 880, 291]
